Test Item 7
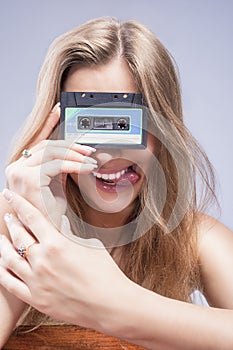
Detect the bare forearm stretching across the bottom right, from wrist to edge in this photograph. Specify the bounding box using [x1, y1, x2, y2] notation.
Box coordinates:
[106, 284, 233, 350]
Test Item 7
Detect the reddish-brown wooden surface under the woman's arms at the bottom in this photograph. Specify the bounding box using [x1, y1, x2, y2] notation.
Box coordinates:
[3, 325, 144, 350]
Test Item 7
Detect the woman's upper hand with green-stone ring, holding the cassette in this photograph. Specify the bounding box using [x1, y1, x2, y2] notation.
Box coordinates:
[6, 106, 97, 226]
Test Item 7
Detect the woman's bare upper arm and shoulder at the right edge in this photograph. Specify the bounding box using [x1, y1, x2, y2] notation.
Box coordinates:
[198, 214, 233, 309]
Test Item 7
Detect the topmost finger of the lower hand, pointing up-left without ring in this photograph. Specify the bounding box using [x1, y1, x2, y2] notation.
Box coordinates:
[2, 189, 58, 243]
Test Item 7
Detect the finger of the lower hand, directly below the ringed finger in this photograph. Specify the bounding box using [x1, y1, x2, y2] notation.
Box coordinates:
[0, 236, 32, 282]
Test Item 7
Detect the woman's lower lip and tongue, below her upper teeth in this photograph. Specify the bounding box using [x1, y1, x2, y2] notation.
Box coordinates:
[92, 168, 140, 193]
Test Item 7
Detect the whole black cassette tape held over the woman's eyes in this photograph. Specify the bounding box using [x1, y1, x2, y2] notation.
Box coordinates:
[60, 92, 147, 148]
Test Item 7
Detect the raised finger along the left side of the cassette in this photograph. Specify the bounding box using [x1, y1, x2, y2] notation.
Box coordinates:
[30, 102, 61, 148]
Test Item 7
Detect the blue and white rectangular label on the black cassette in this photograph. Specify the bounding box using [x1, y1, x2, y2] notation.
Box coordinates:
[65, 107, 142, 144]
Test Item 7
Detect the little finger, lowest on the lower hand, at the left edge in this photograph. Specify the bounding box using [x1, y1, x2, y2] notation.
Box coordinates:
[0, 264, 32, 304]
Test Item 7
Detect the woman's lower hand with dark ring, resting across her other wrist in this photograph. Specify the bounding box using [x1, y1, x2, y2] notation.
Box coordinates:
[0, 190, 133, 333]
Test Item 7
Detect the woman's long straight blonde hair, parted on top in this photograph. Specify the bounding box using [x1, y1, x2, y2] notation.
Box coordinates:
[10, 18, 217, 326]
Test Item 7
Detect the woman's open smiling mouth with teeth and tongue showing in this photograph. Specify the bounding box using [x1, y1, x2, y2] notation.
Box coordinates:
[92, 164, 140, 190]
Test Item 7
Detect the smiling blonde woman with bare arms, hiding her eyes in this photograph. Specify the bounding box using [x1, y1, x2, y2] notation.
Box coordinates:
[0, 18, 233, 350]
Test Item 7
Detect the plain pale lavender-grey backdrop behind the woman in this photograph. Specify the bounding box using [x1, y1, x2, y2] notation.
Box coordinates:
[0, 0, 233, 228]
